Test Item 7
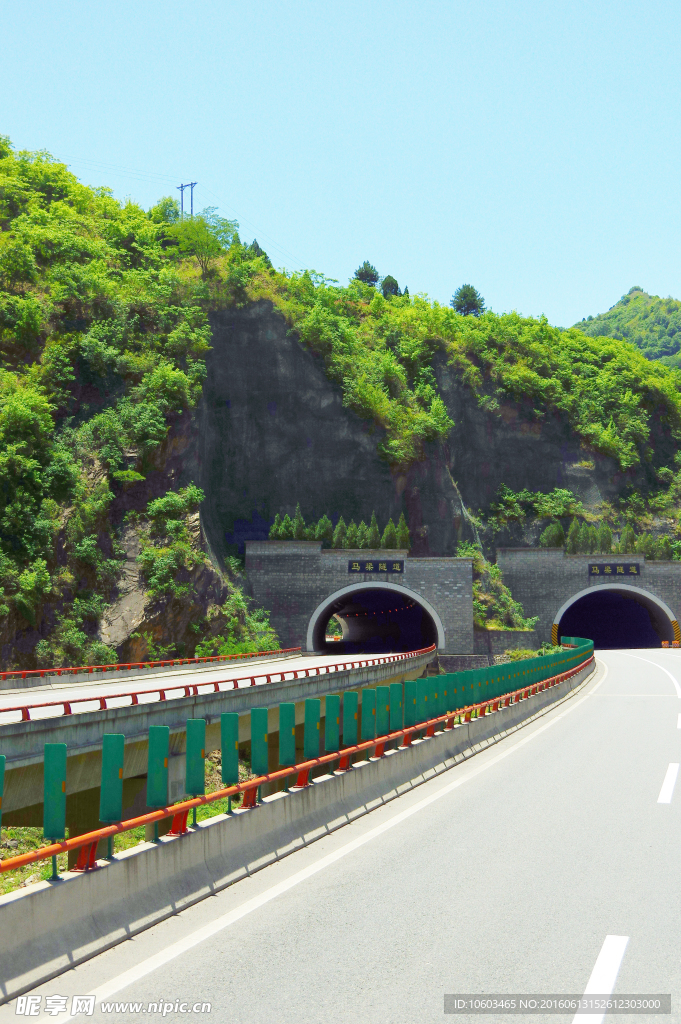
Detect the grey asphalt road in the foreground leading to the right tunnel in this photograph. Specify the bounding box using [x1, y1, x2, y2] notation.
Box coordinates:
[5, 650, 681, 1024]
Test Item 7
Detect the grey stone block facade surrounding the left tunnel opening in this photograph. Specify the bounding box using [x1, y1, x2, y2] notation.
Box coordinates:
[246, 541, 474, 654]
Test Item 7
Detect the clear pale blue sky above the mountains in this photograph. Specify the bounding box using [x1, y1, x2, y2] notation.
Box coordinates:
[0, 0, 681, 326]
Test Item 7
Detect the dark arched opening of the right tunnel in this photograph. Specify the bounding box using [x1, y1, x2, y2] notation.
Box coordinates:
[558, 588, 674, 650]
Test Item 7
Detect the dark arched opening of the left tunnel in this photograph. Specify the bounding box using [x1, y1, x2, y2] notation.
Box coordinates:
[312, 587, 437, 654]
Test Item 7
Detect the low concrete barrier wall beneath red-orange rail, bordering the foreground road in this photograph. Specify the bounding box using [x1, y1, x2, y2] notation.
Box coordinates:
[0, 666, 594, 1001]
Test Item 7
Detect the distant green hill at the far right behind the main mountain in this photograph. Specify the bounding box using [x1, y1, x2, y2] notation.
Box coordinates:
[574, 287, 681, 366]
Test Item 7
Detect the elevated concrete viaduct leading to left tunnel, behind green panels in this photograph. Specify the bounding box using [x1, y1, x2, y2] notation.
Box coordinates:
[0, 651, 433, 835]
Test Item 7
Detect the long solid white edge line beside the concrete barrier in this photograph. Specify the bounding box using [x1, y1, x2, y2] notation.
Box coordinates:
[40, 662, 608, 1024]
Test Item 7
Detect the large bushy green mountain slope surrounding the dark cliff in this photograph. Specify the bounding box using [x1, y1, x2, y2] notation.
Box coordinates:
[0, 138, 681, 666]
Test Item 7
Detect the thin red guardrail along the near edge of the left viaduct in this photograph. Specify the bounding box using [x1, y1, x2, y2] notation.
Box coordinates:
[0, 644, 435, 728]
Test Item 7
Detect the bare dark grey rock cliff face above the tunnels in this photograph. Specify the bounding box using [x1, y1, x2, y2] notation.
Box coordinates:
[196, 302, 623, 560]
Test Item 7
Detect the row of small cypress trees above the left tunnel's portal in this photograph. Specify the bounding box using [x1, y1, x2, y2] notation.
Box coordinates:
[269, 505, 411, 551]
